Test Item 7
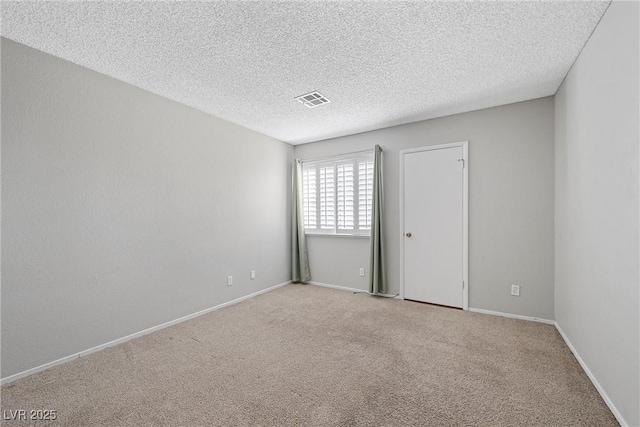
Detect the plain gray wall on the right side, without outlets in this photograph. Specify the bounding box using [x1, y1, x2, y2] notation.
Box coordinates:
[555, 1, 640, 426]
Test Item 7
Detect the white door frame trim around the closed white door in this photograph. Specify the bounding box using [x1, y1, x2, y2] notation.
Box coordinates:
[399, 141, 469, 310]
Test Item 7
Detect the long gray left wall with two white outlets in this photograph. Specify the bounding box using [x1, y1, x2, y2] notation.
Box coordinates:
[2, 39, 293, 377]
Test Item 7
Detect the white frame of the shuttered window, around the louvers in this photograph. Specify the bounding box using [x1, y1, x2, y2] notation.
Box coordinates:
[302, 150, 374, 238]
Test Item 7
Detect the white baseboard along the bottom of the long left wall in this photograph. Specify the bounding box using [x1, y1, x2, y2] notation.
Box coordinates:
[0, 281, 291, 385]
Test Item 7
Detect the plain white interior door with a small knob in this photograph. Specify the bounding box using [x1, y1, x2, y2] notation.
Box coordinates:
[402, 145, 467, 308]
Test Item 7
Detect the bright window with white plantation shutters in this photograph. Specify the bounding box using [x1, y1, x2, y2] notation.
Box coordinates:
[302, 152, 373, 235]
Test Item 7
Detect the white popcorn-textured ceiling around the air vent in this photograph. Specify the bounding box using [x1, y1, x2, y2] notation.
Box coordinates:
[2, 0, 609, 144]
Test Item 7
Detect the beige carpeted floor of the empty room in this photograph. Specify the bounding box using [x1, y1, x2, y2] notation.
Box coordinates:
[2, 285, 618, 426]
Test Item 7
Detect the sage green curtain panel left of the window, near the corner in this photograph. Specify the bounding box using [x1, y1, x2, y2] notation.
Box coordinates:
[291, 159, 311, 283]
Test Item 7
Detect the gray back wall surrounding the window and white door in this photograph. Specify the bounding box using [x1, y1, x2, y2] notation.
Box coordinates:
[294, 98, 554, 319]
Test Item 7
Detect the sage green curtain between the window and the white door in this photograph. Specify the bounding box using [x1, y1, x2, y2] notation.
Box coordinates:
[369, 145, 387, 294]
